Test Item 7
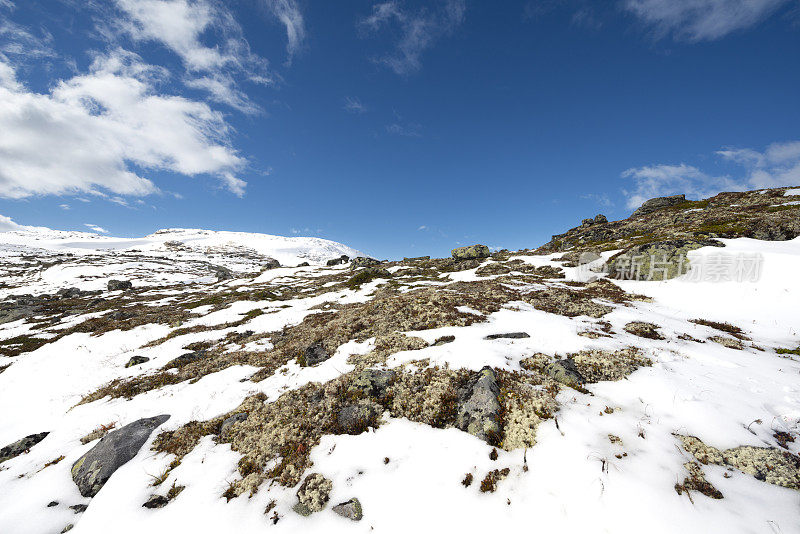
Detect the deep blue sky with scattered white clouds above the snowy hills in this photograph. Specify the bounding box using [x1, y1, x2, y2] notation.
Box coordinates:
[0, 0, 800, 258]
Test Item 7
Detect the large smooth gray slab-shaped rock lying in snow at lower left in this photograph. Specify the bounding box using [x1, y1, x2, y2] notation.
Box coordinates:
[72, 415, 170, 497]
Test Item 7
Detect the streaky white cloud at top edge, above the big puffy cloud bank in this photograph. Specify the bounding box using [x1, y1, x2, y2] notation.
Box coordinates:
[106, 0, 274, 113]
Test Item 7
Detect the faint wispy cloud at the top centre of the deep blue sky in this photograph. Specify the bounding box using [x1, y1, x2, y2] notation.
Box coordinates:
[358, 0, 466, 76]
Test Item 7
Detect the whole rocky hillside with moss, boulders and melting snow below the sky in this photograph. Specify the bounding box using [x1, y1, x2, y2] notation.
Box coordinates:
[0, 188, 800, 533]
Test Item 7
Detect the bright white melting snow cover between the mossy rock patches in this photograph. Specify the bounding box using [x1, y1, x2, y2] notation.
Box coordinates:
[0, 227, 800, 534]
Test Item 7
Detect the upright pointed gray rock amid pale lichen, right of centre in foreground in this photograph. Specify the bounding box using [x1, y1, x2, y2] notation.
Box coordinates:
[456, 366, 502, 444]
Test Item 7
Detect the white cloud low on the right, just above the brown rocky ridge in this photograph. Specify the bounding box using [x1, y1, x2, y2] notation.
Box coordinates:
[622, 141, 800, 208]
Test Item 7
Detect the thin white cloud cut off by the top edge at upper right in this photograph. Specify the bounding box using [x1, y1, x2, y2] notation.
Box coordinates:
[624, 0, 791, 41]
